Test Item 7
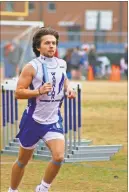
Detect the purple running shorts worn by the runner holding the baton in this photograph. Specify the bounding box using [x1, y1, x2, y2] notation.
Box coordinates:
[16, 110, 63, 147]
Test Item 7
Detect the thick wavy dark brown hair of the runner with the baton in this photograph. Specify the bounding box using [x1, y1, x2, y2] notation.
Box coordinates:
[32, 27, 59, 57]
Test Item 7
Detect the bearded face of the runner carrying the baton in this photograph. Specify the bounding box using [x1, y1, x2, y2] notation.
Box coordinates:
[38, 35, 56, 57]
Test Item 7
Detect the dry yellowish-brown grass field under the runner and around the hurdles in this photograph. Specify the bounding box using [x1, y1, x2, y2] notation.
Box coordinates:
[1, 81, 127, 192]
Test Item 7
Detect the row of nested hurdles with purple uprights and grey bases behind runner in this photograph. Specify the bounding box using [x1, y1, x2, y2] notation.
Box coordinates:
[1, 79, 122, 163]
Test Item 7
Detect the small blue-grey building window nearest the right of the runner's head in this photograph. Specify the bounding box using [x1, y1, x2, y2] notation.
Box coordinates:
[68, 26, 80, 41]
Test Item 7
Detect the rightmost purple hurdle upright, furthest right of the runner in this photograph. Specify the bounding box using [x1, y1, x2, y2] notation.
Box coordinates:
[77, 84, 81, 145]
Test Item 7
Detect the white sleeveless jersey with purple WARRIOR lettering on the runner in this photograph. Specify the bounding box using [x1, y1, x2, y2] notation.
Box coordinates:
[27, 56, 66, 124]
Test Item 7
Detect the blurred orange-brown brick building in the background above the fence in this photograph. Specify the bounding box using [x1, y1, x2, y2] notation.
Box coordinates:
[1, 1, 128, 46]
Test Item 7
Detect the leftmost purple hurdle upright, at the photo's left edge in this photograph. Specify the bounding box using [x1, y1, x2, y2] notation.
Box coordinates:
[2, 86, 6, 148]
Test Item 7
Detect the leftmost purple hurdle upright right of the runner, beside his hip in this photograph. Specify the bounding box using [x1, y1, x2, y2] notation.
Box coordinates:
[64, 95, 68, 157]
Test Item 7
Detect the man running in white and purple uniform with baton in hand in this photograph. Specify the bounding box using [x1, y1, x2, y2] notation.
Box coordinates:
[8, 27, 75, 192]
